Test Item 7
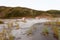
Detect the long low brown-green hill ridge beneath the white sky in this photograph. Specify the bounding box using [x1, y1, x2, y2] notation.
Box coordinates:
[0, 6, 60, 18]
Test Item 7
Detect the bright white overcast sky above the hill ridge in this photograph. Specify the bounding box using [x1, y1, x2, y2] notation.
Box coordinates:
[0, 0, 60, 10]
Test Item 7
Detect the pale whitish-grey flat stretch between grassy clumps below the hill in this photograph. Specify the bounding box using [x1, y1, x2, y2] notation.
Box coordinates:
[0, 18, 56, 40]
